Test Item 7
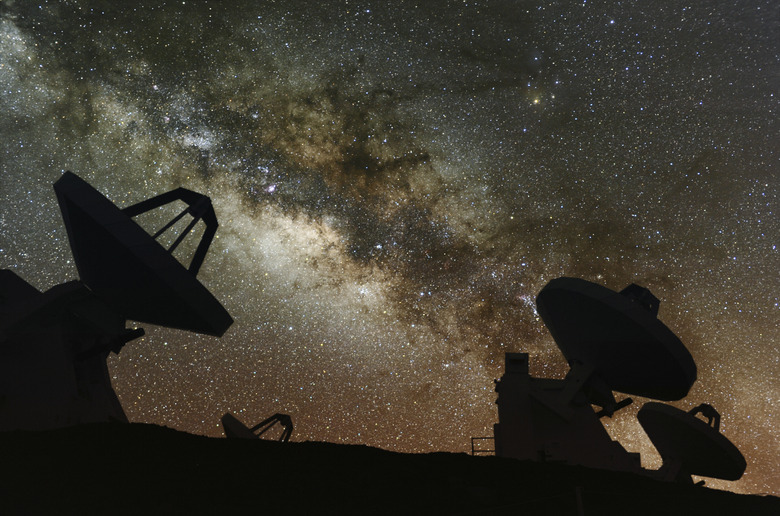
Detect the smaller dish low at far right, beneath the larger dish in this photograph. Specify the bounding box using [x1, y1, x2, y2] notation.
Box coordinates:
[637, 402, 747, 480]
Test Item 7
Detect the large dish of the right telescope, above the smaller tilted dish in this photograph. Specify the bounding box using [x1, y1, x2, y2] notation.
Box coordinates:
[536, 277, 696, 400]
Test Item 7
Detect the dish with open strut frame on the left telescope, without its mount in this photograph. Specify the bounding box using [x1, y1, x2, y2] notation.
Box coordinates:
[54, 172, 233, 336]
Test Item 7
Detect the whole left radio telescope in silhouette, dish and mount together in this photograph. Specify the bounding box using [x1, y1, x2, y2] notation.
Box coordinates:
[0, 172, 233, 430]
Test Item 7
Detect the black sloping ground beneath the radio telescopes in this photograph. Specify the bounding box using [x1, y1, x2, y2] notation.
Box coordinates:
[0, 424, 780, 516]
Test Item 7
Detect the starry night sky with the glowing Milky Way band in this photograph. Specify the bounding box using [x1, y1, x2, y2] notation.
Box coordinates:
[0, 0, 780, 495]
